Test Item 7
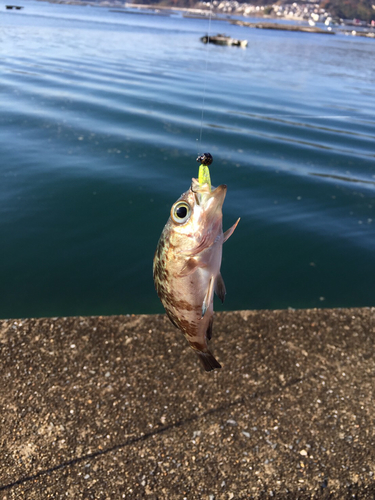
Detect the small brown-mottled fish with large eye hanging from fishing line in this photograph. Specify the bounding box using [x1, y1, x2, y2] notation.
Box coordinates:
[153, 178, 240, 372]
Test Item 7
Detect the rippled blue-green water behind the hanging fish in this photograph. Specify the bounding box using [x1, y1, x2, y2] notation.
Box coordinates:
[0, 0, 375, 318]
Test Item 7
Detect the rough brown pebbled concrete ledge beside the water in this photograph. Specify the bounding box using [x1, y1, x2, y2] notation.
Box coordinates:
[0, 308, 375, 500]
